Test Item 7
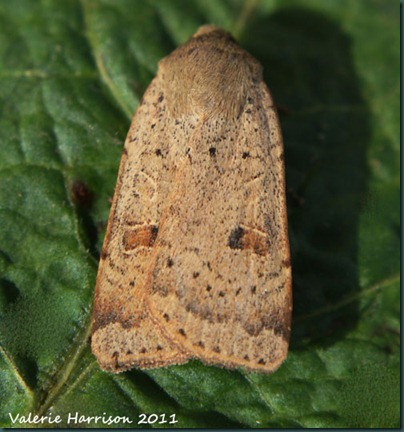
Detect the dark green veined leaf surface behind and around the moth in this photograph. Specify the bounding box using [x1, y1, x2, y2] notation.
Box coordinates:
[0, 0, 400, 427]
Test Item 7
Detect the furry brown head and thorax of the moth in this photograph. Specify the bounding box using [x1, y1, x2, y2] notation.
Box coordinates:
[159, 25, 262, 119]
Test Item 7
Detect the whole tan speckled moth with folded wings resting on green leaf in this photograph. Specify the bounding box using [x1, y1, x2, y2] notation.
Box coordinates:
[92, 26, 292, 372]
